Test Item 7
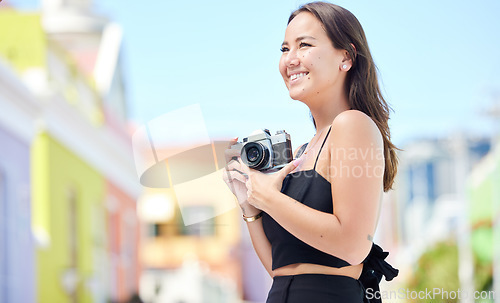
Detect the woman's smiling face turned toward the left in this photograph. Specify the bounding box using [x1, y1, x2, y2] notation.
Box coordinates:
[279, 12, 351, 104]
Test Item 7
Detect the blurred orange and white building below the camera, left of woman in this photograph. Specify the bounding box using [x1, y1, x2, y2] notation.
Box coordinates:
[139, 160, 250, 303]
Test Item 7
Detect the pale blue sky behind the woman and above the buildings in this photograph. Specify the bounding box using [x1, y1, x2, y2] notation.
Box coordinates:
[5, 0, 500, 146]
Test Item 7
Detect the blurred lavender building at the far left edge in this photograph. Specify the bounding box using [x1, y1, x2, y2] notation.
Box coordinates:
[0, 52, 39, 303]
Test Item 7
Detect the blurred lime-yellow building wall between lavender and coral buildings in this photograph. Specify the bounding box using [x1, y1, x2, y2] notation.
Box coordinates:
[32, 133, 106, 302]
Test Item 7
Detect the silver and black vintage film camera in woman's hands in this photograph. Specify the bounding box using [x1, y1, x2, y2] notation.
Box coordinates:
[231, 129, 293, 172]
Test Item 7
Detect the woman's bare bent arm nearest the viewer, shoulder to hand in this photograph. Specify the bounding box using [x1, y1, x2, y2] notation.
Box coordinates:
[247, 111, 384, 264]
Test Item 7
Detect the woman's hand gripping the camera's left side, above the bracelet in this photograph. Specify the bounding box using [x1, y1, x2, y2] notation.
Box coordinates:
[222, 139, 260, 217]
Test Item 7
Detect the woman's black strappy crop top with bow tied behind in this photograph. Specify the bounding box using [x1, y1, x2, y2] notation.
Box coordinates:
[262, 128, 398, 302]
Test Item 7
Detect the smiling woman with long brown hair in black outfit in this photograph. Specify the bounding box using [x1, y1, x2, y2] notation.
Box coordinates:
[225, 2, 397, 303]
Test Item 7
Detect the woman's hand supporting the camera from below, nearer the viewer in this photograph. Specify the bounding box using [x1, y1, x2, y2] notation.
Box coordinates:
[242, 158, 302, 211]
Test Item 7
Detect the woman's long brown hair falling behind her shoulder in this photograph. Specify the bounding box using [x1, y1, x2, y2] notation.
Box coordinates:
[288, 2, 398, 191]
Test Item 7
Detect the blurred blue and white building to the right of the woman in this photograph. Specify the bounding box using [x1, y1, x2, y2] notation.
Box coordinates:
[375, 133, 491, 302]
